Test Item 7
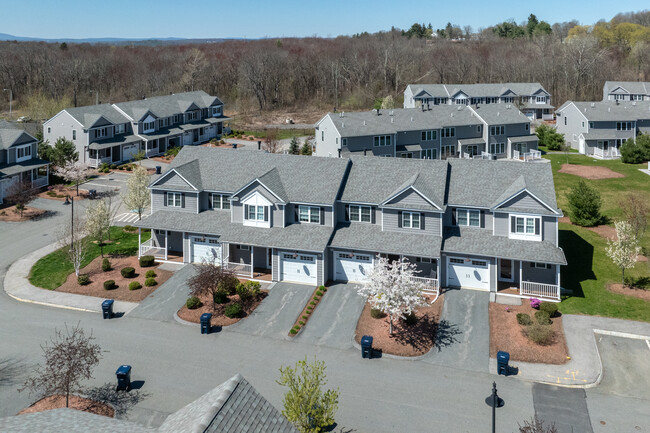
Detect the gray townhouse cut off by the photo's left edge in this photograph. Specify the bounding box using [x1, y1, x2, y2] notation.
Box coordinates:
[0, 120, 49, 204]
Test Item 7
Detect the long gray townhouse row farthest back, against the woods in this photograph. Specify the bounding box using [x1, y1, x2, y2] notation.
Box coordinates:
[404, 83, 555, 120]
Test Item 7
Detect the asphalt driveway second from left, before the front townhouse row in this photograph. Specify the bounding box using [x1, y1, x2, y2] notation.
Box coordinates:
[224, 282, 316, 339]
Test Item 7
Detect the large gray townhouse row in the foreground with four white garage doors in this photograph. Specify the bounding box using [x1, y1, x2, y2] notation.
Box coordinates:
[136, 147, 566, 300]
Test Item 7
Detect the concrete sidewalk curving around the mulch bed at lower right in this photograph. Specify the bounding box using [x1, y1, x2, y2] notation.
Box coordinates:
[490, 314, 650, 388]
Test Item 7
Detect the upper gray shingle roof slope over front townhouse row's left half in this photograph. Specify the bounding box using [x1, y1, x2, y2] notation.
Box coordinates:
[159, 146, 348, 205]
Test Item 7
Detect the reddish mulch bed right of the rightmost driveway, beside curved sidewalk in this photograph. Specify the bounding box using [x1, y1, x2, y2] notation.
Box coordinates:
[488, 300, 569, 365]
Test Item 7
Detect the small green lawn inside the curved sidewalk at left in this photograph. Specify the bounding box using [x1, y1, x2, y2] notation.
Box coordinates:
[29, 227, 151, 290]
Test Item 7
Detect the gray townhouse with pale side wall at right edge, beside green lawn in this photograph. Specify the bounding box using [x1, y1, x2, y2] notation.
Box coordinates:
[556, 100, 650, 159]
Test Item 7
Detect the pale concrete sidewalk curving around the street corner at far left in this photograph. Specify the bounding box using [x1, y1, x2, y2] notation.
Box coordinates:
[4, 244, 138, 314]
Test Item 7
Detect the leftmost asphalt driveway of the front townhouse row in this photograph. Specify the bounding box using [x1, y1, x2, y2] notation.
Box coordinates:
[129, 263, 194, 322]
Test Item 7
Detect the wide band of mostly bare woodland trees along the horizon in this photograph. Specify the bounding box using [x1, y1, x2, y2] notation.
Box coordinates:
[0, 13, 650, 119]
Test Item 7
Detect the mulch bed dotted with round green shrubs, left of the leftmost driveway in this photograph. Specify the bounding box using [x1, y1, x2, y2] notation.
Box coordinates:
[56, 256, 173, 302]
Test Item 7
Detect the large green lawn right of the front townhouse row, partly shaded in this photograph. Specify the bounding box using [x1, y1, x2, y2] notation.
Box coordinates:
[544, 153, 650, 322]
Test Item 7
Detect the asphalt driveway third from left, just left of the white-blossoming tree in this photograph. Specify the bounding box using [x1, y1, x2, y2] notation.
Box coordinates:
[296, 284, 365, 349]
